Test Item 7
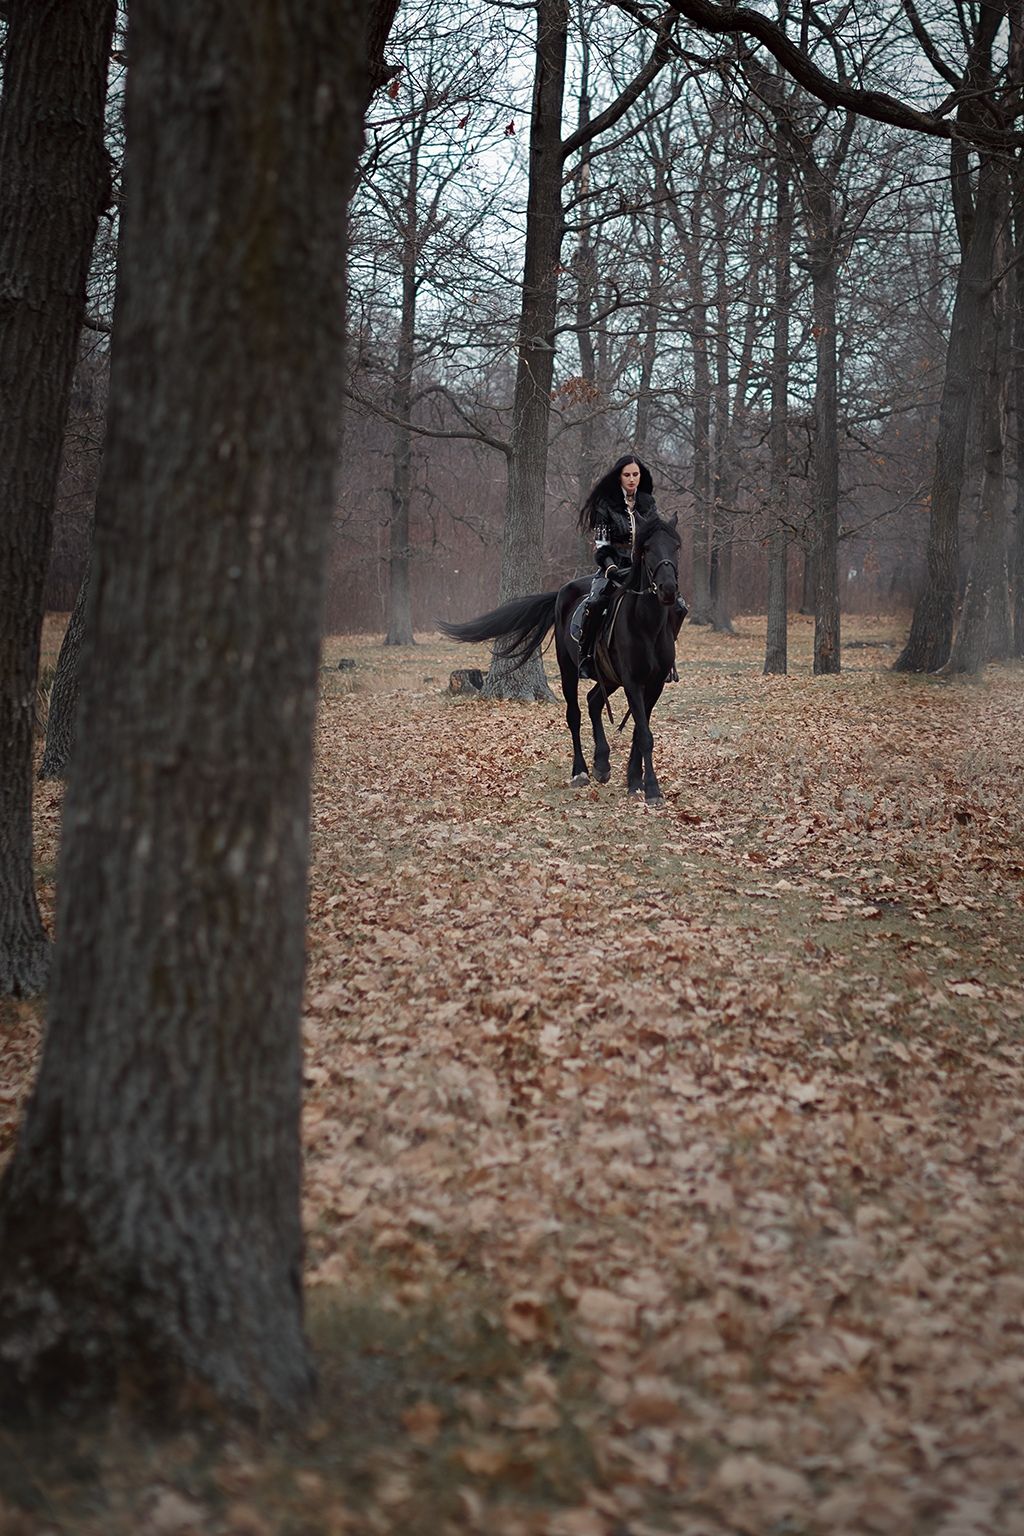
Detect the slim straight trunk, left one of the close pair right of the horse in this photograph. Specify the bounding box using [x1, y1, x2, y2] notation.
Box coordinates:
[765, 143, 792, 674]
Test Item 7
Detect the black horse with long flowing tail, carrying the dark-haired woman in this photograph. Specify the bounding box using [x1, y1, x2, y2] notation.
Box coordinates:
[439, 513, 686, 805]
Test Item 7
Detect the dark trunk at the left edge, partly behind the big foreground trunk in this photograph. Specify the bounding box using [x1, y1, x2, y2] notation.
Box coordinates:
[0, 0, 114, 995]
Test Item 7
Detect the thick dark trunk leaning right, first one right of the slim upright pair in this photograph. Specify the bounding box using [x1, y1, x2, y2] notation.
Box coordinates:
[894, 155, 1003, 671]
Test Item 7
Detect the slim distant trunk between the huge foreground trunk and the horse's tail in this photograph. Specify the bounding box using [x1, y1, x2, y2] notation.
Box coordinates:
[384, 129, 419, 645]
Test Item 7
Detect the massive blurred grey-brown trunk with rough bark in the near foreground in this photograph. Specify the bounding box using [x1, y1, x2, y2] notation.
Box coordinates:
[0, 0, 365, 1415]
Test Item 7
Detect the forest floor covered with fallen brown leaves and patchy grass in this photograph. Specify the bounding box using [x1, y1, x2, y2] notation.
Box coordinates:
[0, 617, 1024, 1536]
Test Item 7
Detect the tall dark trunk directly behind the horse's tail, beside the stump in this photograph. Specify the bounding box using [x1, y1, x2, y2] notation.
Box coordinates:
[484, 0, 568, 699]
